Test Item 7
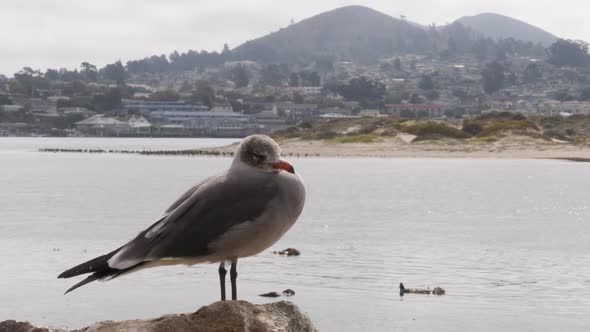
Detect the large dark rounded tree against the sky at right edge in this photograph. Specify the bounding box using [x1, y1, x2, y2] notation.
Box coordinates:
[547, 39, 590, 67]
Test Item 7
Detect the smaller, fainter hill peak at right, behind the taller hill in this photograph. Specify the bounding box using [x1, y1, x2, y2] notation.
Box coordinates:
[456, 13, 557, 46]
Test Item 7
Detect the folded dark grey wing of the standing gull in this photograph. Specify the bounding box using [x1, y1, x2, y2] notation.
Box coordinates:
[108, 174, 278, 269]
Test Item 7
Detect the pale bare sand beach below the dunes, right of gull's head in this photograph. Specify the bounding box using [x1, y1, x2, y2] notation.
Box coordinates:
[205, 137, 590, 159]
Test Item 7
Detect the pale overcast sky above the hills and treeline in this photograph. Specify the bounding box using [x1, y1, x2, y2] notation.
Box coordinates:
[0, 0, 590, 76]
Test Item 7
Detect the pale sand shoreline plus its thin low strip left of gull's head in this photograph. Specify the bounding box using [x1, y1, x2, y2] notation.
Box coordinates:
[38, 136, 590, 161]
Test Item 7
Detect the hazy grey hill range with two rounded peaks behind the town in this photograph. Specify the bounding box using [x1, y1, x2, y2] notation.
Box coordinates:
[126, 6, 556, 74]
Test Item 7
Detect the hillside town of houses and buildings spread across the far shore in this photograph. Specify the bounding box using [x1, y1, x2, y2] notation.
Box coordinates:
[0, 51, 590, 137]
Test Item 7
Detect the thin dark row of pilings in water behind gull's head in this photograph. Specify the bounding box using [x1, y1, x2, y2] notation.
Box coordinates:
[39, 148, 320, 158]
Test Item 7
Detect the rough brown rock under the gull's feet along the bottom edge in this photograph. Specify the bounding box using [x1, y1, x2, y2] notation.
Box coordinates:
[0, 301, 318, 332]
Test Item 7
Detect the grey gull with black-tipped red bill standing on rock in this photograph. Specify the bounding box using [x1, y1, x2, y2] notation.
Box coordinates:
[58, 135, 305, 301]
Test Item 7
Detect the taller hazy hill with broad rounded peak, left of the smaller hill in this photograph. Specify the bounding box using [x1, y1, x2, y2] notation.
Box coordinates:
[232, 6, 430, 63]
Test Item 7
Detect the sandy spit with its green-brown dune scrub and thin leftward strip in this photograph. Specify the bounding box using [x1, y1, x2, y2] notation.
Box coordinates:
[39, 112, 590, 161]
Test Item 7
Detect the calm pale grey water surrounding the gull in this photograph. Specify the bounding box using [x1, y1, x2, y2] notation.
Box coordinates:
[0, 138, 590, 332]
